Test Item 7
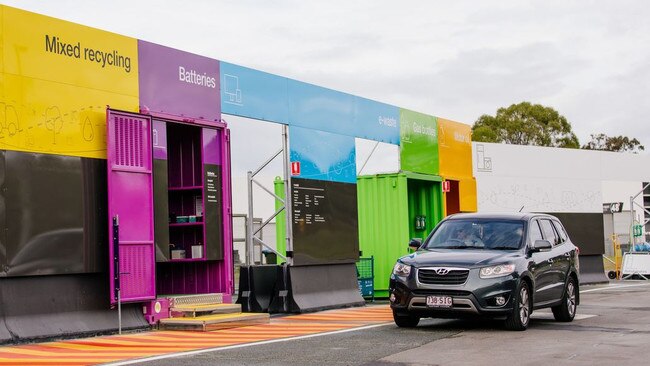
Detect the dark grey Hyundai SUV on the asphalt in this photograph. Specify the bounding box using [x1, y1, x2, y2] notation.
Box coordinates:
[389, 213, 580, 330]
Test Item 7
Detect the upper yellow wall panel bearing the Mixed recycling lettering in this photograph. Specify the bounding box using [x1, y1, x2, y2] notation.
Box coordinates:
[2, 7, 138, 96]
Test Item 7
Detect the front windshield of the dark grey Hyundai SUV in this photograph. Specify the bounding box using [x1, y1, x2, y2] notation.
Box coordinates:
[422, 219, 524, 250]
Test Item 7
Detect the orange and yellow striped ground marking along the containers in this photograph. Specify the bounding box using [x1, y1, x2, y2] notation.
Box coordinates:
[0, 306, 392, 366]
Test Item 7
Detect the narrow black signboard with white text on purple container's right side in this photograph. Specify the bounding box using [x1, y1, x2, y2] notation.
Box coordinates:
[203, 164, 223, 260]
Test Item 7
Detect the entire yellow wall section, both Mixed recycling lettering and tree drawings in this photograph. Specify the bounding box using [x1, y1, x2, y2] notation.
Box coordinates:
[0, 6, 139, 158]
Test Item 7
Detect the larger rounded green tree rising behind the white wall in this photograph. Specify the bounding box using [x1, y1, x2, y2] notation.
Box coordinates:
[472, 102, 580, 149]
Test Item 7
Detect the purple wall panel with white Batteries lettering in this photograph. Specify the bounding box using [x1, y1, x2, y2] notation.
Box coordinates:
[138, 41, 221, 121]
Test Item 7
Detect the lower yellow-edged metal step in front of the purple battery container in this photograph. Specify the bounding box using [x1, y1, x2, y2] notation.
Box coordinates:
[160, 313, 270, 332]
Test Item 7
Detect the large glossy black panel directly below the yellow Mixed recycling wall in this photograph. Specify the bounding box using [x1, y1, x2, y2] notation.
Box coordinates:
[0, 151, 109, 277]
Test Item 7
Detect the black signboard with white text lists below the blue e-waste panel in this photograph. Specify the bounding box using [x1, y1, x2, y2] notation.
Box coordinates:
[291, 178, 359, 265]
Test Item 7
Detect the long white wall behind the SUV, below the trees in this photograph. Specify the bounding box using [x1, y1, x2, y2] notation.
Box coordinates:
[472, 142, 650, 212]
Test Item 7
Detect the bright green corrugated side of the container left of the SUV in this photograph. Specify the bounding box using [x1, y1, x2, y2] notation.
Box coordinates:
[357, 174, 409, 296]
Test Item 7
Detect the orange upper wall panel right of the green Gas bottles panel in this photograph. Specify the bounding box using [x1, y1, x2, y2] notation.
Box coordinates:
[438, 118, 472, 178]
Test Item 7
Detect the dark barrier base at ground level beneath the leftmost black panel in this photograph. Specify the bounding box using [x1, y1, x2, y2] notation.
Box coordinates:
[0, 274, 149, 343]
